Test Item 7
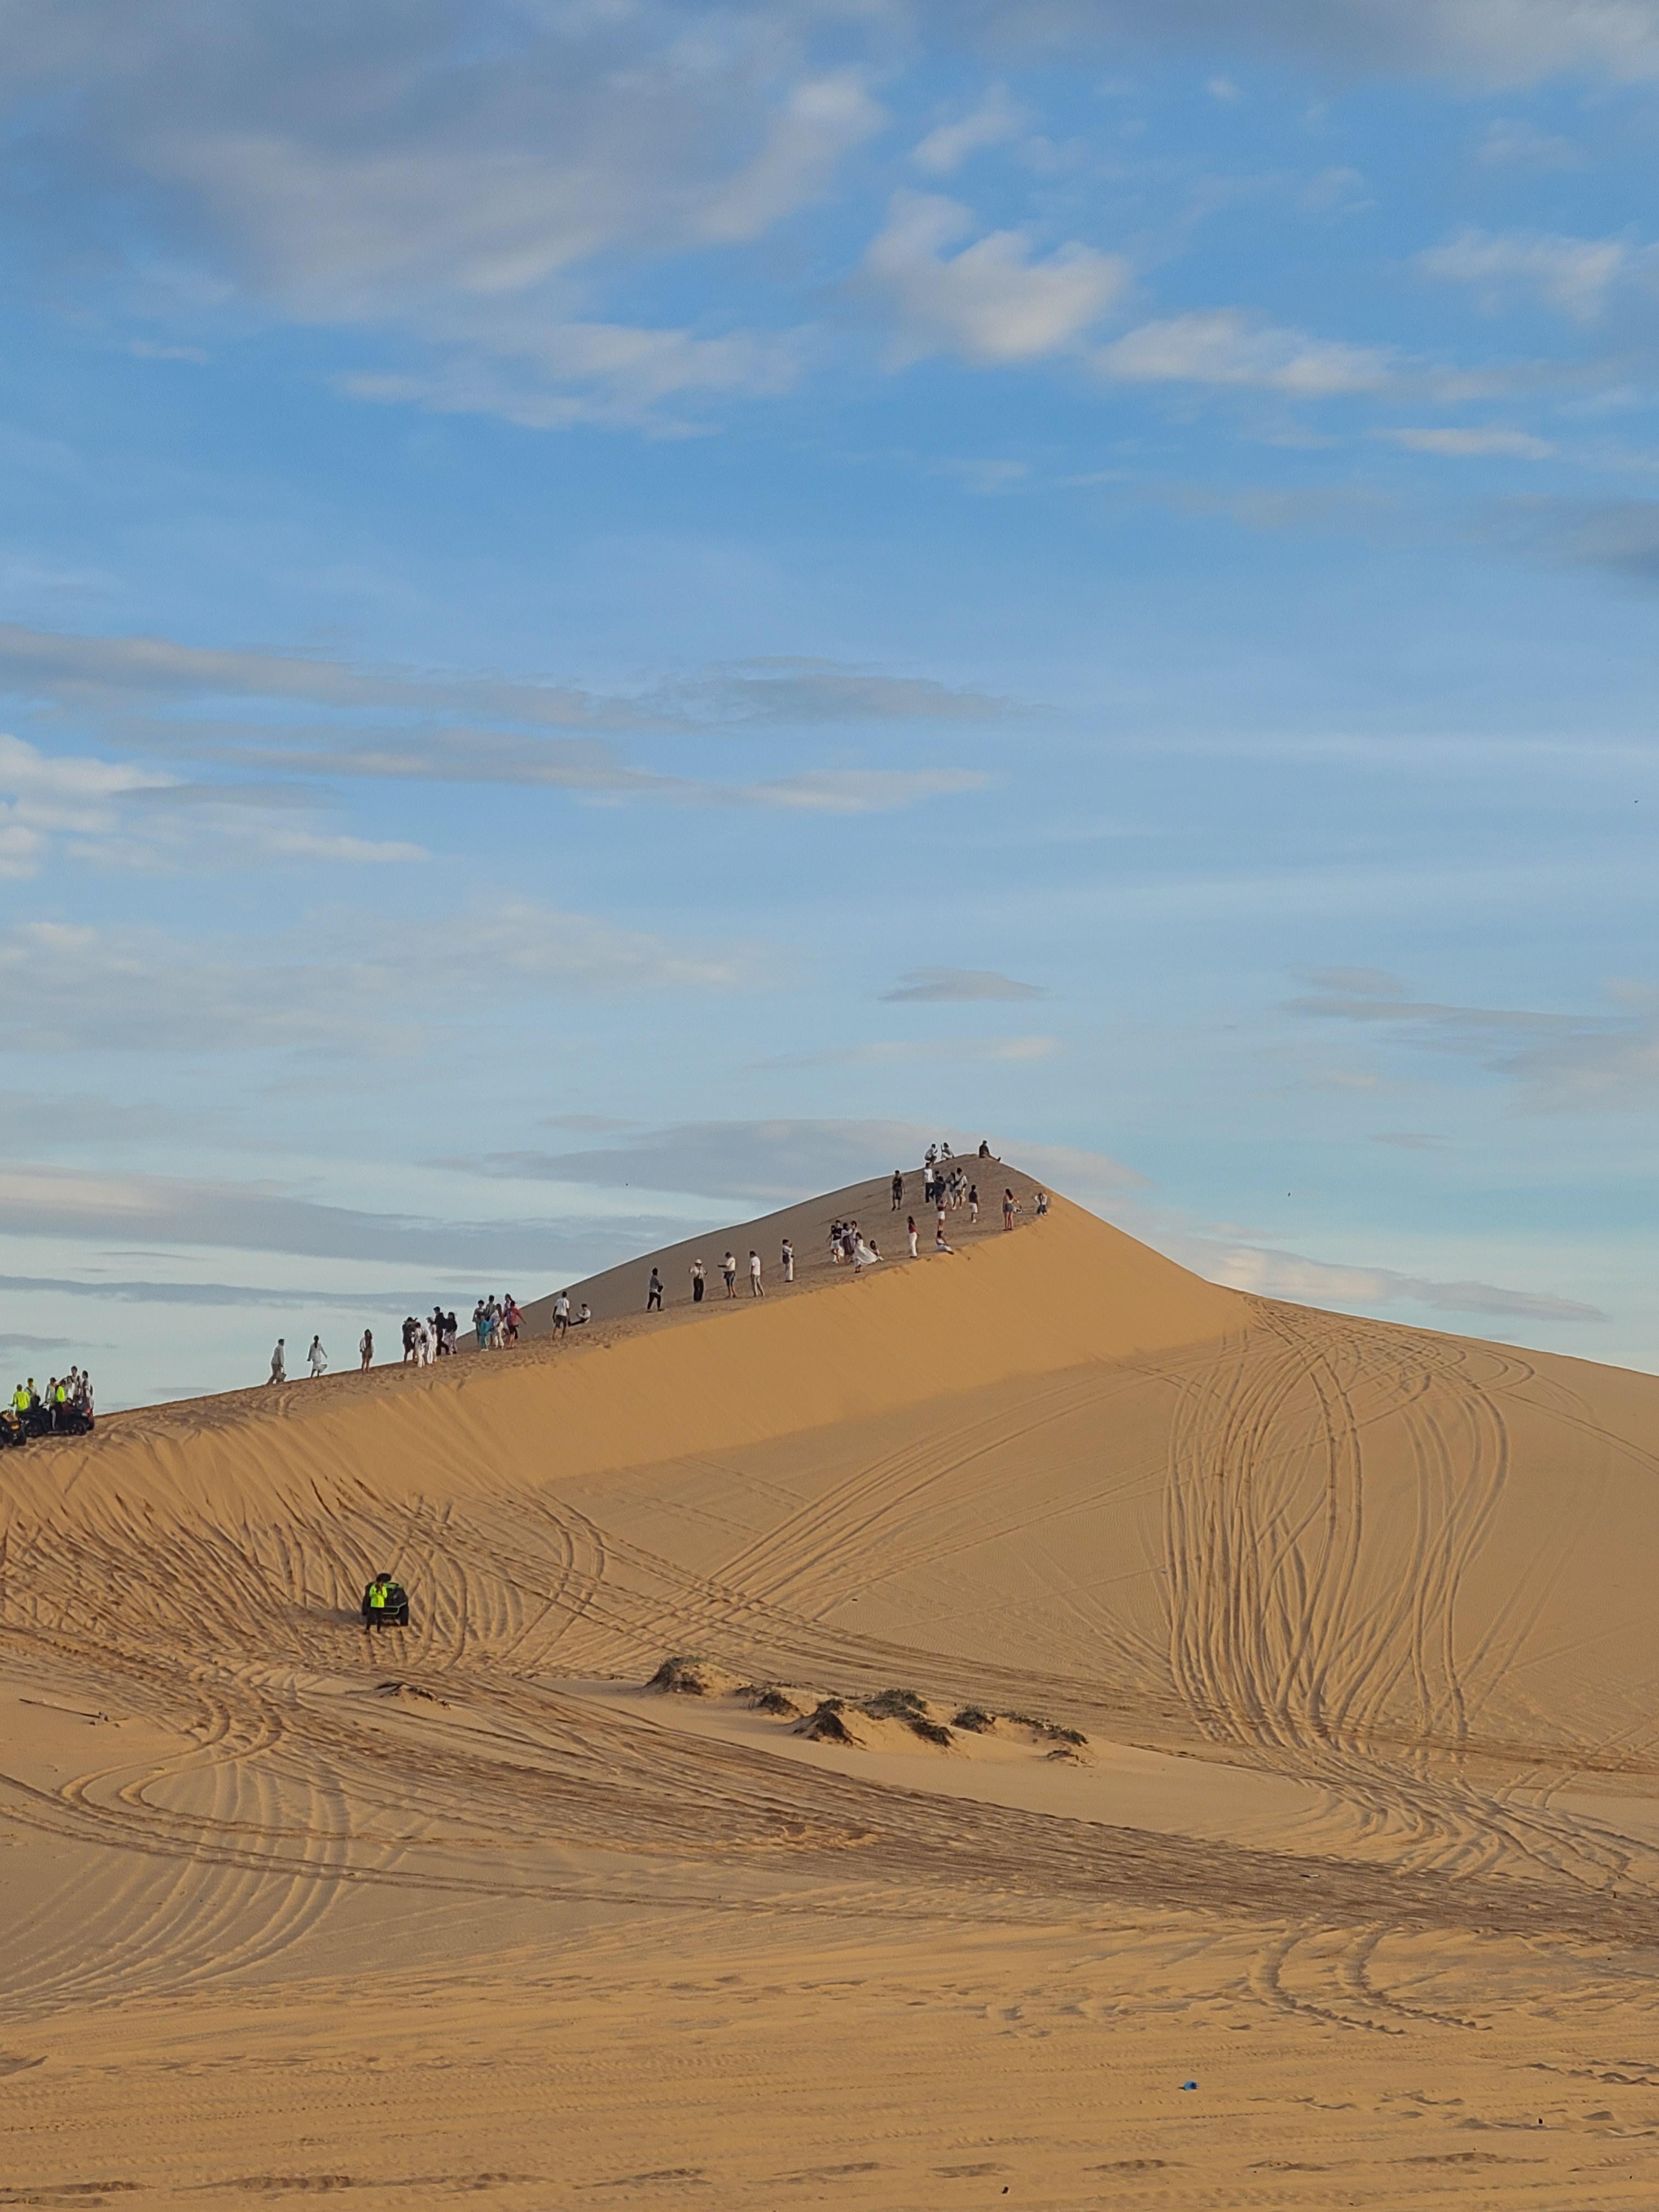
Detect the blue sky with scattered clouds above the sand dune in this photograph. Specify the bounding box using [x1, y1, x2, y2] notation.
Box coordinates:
[0, 0, 1659, 1407]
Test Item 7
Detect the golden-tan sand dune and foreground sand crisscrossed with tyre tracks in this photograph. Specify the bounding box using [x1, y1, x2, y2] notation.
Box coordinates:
[0, 1164, 1659, 2212]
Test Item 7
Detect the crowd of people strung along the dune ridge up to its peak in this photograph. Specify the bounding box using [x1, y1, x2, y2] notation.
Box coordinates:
[253, 1142, 1048, 1383]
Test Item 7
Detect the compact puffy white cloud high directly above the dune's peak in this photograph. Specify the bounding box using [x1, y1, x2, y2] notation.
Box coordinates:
[860, 193, 1128, 365]
